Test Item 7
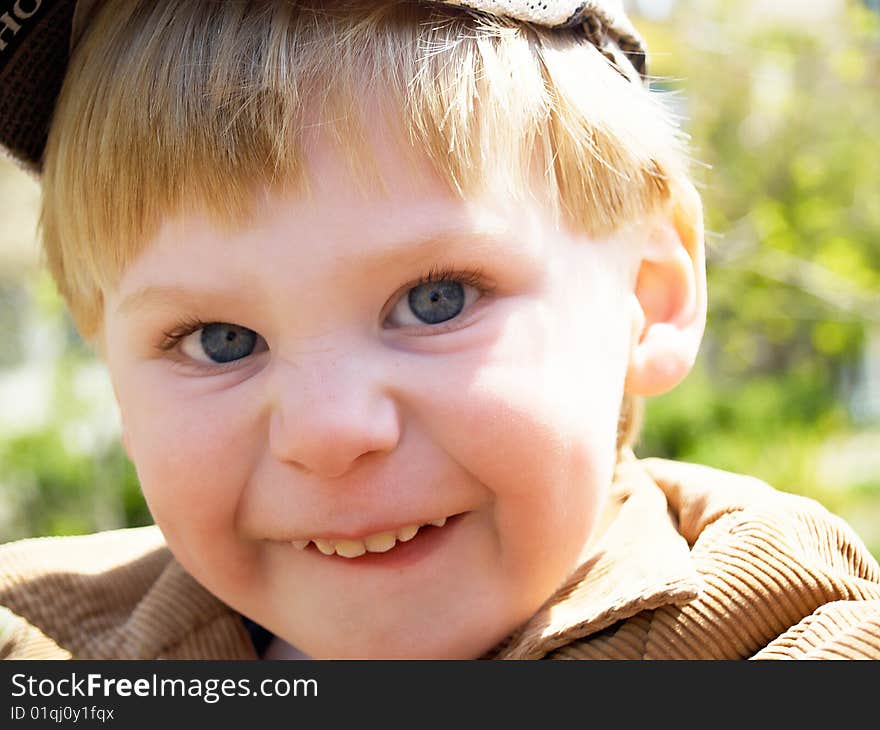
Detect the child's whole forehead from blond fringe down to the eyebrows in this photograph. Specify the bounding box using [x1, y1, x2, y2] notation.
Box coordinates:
[107, 96, 652, 322]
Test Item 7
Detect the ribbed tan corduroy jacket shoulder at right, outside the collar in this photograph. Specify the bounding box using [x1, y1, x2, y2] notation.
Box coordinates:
[536, 459, 880, 660]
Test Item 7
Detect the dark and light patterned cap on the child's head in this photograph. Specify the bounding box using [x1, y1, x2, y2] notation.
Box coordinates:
[0, 0, 646, 175]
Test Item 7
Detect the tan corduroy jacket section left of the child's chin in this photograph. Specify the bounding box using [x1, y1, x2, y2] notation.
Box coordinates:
[0, 527, 256, 659]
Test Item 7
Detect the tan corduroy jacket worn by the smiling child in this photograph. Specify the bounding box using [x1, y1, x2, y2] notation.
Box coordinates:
[0, 459, 880, 659]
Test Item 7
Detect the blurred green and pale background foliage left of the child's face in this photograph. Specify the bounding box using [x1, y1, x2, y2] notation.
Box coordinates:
[0, 165, 152, 542]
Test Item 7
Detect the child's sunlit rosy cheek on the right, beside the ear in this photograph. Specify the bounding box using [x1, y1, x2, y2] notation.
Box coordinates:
[402, 300, 626, 571]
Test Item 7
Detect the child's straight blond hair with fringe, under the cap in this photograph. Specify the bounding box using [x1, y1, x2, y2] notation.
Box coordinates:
[41, 0, 686, 450]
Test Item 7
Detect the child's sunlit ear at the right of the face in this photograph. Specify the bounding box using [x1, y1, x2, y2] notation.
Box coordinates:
[626, 183, 706, 396]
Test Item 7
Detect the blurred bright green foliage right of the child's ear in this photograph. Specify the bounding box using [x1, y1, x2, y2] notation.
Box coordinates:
[636, 0, 880, 556]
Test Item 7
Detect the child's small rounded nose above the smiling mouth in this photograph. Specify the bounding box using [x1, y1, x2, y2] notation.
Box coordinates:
[269, 346, 401, 479]
